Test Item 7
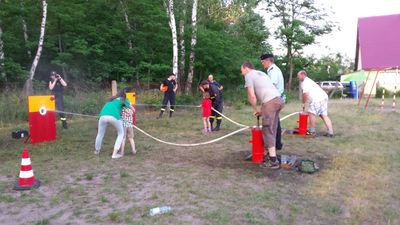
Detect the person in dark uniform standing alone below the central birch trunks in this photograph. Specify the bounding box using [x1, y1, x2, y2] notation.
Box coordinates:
[158, 73, 178, 118]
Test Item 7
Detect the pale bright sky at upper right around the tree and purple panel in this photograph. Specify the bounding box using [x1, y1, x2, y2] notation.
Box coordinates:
[256, 0, 400, 59]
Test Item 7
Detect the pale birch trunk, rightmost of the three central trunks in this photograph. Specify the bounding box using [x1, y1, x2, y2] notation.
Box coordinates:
[186, 0, 198, 93]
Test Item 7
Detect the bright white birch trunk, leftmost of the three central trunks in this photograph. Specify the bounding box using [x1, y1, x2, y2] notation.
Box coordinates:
[166, 0, 179, 80]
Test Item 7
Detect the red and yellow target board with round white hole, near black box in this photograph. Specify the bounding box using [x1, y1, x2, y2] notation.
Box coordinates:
[28, 95, 57, 144]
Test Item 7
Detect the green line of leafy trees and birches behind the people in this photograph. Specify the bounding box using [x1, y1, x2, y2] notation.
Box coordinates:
[0, 0, 345, 93]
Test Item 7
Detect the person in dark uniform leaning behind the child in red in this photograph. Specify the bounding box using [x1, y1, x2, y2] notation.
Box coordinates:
[200, 81, 224, 131]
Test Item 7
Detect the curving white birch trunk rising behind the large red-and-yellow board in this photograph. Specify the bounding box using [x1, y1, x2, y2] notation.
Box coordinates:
[24, 0, 47, 95]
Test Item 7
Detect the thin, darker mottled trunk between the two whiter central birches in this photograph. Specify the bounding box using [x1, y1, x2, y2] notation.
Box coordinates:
[178, 0, 186, 90]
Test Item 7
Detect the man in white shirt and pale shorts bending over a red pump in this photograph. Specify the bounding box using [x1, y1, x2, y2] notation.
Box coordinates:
[297, 70, 333, 137]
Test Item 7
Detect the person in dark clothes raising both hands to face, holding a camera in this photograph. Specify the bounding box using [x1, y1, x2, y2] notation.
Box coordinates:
[49, 71, 68, 129]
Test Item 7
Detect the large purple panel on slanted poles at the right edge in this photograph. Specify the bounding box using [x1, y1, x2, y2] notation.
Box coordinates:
[354, 14, 400, 108]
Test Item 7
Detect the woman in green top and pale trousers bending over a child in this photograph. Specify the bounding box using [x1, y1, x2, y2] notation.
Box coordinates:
[94, 89, 131, 159]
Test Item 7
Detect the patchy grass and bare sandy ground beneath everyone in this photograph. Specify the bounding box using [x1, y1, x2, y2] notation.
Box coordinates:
[0, 100, 400, 224]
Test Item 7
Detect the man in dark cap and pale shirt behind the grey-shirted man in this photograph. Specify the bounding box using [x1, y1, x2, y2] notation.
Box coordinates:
[260, 53, 285, 150]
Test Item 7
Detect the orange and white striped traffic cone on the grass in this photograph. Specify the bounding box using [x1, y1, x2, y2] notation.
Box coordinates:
[14, 148, 40, 191]
